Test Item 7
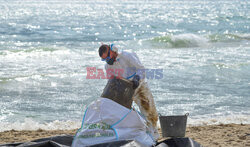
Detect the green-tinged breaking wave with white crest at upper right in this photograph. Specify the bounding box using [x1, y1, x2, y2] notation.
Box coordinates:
[147, 34, 250, 48]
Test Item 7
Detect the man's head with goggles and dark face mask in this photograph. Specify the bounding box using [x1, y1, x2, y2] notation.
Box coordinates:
[99, 44, 117, 65]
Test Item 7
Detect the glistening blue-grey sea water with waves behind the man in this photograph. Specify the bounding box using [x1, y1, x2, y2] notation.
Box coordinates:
[0, 0, 250, 131]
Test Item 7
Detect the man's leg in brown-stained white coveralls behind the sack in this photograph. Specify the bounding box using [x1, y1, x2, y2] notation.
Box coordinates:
[133, 81, 159, 140]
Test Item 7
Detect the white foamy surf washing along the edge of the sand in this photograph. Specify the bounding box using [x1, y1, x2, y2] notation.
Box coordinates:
[0, 115, 250, 132]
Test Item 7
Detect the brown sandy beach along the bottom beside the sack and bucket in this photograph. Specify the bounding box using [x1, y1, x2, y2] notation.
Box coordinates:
[0, 124, 250, 147]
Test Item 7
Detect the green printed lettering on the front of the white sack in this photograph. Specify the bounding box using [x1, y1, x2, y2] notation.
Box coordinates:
[78, 122, 115, 138]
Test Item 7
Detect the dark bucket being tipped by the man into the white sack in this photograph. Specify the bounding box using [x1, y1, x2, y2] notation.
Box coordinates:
[101, 77, 135, 109]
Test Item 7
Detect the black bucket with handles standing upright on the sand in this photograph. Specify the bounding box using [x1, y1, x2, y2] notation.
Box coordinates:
[160, 113, 189, 138]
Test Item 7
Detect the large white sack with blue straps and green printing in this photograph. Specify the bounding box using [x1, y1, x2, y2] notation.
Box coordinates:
[72, 98, 155, 147]
